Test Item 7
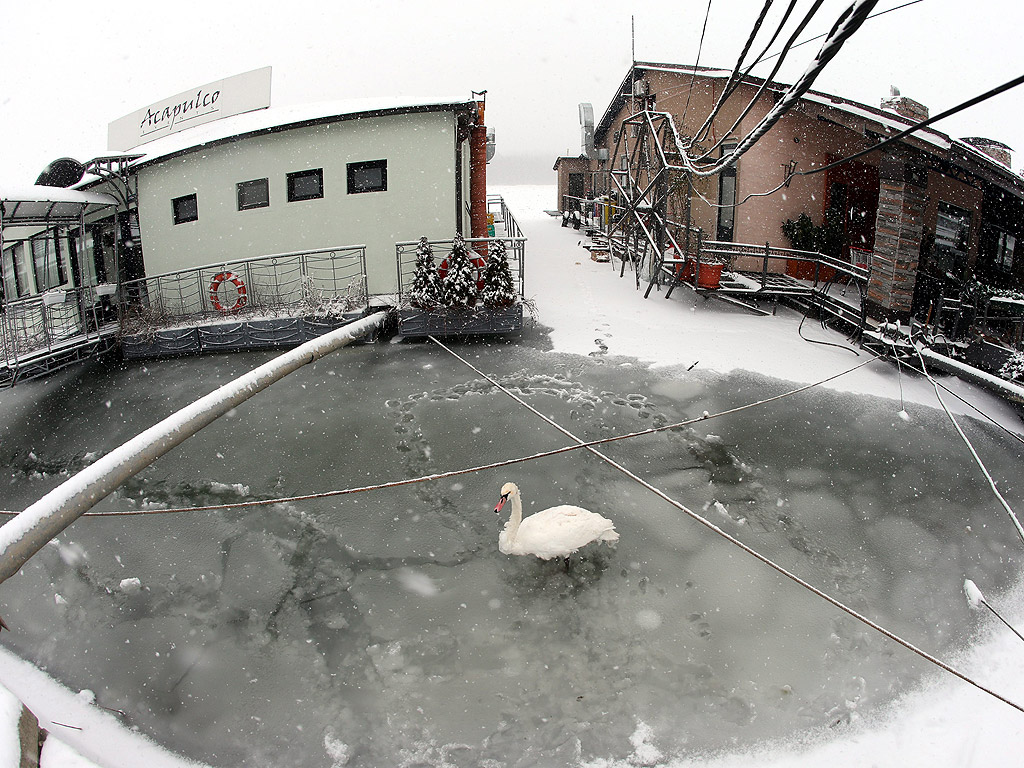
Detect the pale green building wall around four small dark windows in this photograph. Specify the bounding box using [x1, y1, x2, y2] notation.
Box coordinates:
[138, 112, 460, 294]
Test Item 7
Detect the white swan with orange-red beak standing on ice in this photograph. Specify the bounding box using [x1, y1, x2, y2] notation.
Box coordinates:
[495, 482, 618, 560]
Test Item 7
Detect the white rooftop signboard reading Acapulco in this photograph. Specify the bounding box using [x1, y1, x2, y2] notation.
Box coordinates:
[106, 67, 270, 152]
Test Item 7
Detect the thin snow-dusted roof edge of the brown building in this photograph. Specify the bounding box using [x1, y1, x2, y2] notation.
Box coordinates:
[594, 61, 1024, 195]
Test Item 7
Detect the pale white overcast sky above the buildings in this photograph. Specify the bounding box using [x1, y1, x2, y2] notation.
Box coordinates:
[6, 0, 1024, 185]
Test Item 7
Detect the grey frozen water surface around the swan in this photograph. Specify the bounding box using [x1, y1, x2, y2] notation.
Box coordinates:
[0, 339, 1022, 767]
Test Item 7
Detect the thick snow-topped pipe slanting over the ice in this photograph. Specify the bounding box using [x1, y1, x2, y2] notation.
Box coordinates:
[0, 312, 387, 582]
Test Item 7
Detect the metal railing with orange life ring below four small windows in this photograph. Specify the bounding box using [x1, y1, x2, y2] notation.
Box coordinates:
[120, 245, 368, 331]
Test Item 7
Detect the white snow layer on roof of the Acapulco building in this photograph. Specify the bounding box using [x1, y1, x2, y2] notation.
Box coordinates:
[119, 97, 475, 166]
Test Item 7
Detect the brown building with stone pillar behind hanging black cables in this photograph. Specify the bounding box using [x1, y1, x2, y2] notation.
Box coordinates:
[569, 62, 1024, 317]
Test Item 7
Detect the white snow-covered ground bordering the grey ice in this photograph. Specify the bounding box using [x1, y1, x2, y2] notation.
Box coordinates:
[0, 186, 1024, 768]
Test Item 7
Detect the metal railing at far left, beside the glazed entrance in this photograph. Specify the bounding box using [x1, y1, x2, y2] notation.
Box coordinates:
[0, 288, 117, 368]
